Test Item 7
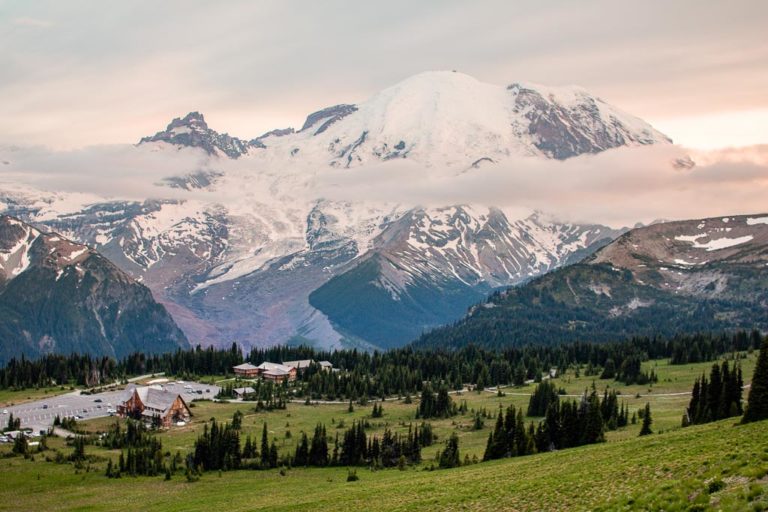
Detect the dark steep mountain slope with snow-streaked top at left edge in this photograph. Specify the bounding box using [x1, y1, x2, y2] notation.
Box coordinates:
[0, 216, 189, 359]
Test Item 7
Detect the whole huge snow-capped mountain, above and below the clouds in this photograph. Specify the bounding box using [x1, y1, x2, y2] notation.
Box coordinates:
[0, 72, 669, 347]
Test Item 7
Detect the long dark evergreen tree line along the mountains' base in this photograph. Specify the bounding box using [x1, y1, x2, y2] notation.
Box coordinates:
[0, 331, 763, 403]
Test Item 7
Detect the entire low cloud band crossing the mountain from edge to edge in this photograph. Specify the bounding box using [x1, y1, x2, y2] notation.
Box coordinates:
[0, 144, 768, 226]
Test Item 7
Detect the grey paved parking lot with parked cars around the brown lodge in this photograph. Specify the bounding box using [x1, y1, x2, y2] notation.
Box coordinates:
[0, 381, 220, 431]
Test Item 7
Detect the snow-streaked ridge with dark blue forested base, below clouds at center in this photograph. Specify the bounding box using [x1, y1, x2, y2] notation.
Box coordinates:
[309, 206, 620, 347]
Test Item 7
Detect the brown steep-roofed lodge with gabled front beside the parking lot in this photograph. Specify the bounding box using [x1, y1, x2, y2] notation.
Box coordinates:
[117, 385, 192, 428]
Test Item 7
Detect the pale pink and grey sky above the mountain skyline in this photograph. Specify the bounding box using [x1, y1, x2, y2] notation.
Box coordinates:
[0, 0, 768, 149]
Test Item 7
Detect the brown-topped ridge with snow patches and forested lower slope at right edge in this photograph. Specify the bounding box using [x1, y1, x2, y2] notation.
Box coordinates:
[415, 216, 768, 347]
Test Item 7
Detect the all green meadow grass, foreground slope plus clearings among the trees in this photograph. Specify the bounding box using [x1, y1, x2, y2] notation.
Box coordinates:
[0, 357, 768, 511]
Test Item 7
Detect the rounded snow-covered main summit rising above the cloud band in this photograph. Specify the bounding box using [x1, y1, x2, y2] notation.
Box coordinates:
[286, 71, 670, 169]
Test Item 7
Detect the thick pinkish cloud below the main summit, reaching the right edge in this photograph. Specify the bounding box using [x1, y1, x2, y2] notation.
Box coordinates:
[310, 146, 768, 226]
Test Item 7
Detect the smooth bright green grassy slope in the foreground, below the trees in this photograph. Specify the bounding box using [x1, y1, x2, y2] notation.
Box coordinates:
[0, 421, 768, 511]
